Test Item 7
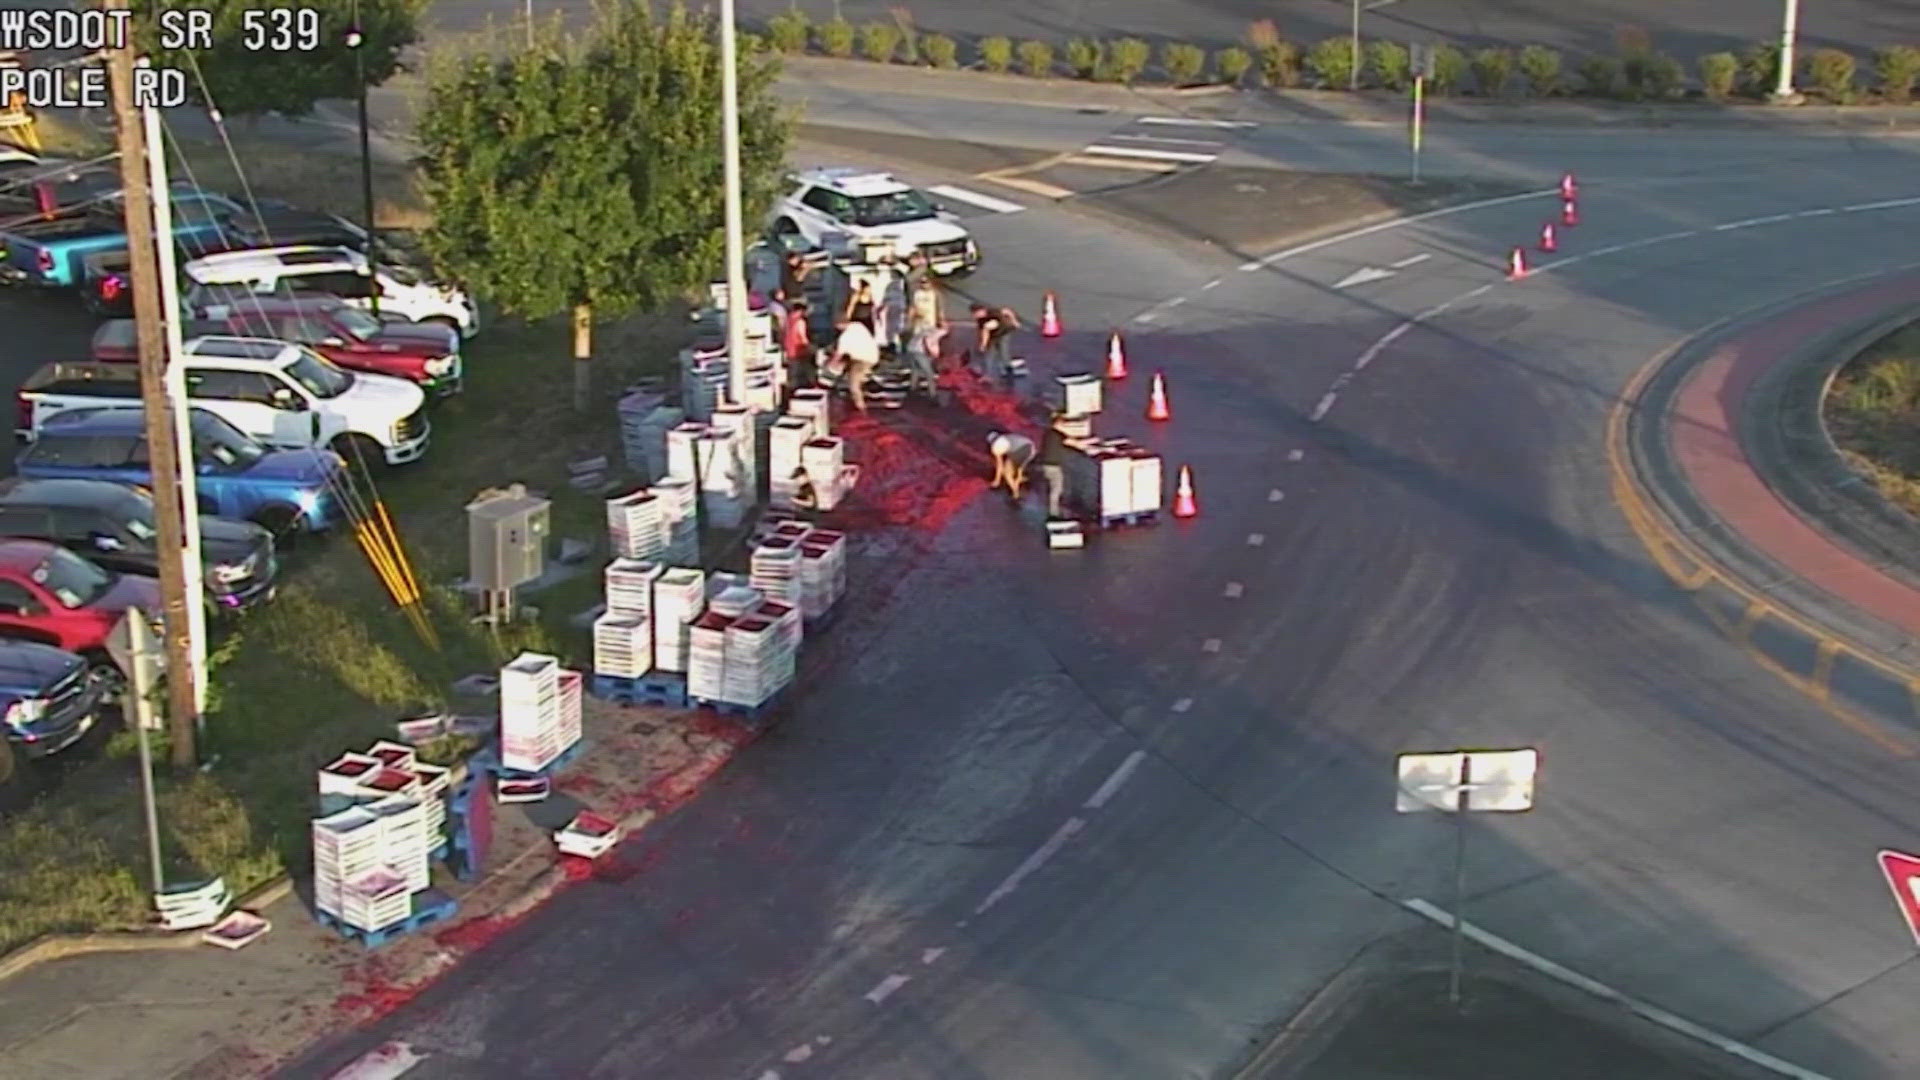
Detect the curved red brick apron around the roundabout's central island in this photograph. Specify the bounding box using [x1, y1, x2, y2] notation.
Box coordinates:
[1667, 273, 1920, 634]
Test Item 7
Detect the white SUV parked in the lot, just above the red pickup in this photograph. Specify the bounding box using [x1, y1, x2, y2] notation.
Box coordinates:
[182, 244, 480, 336]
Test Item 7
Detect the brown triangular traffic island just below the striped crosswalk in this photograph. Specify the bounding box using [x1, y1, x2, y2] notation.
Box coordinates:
[1075, 167, 1523, 258]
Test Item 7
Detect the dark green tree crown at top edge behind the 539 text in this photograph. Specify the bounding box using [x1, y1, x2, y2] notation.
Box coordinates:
[132, 0, 426, 115]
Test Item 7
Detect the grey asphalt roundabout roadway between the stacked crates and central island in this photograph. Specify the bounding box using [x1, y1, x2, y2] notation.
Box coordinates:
[290, 136, 1920, 1080]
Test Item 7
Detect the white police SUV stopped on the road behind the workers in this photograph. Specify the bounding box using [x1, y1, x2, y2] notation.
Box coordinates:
[772, 169, 979, 275]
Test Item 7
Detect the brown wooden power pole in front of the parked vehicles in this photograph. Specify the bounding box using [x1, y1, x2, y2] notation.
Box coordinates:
[106, 0, 204, 769]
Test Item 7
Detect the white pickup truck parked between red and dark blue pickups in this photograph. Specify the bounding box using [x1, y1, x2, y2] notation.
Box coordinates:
[15, 336, 432, 467]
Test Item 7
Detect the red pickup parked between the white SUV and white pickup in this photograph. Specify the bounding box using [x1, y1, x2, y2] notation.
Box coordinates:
[92, 296, 461, 394]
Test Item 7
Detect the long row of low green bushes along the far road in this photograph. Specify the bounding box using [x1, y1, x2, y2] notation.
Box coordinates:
[766, 8, 1920, 104]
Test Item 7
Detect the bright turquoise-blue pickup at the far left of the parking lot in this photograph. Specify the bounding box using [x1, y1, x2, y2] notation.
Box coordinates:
[0, 188, 257, 288]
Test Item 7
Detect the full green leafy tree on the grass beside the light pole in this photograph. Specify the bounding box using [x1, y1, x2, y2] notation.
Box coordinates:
[419, 0, 789, 411]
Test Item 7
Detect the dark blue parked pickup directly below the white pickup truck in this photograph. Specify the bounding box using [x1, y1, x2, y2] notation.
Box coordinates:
[13, 405, 349, 538]
